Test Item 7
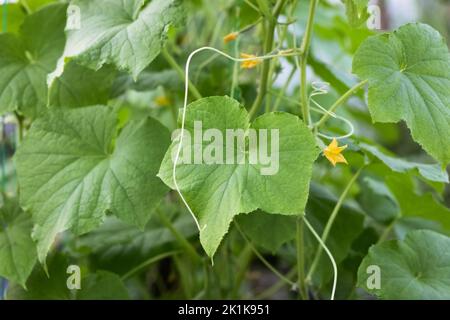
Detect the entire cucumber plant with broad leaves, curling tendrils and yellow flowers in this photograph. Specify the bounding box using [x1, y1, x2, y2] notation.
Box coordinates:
[0, 0, 450, 299]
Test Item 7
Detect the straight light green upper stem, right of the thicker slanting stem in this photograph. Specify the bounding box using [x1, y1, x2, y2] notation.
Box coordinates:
[300, 0, 319, 125]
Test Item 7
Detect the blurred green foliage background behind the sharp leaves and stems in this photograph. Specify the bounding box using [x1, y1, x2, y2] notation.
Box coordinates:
[0, 0, 450, 299]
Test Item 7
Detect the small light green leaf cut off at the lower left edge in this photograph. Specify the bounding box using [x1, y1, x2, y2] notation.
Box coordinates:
[0, 197, 37, 286]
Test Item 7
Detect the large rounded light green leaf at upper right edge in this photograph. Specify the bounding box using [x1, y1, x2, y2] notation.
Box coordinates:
[353, 24, 450, 164]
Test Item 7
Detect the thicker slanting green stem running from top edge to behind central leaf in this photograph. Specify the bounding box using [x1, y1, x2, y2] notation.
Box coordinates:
[249, 0, 286, 118]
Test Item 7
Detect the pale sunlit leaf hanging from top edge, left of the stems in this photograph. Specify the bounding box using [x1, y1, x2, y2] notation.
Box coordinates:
[49, 0, 183, 83]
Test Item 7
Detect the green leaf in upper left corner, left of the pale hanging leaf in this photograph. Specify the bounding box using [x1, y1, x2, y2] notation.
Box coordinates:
[0, 4, 67, 117]
